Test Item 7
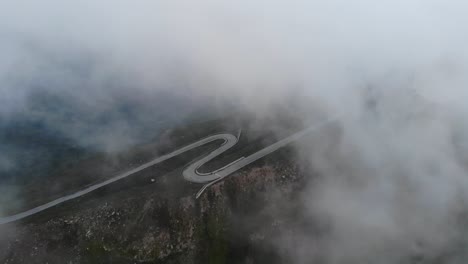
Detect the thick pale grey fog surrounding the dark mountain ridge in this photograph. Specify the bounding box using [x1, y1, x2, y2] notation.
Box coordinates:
[0, 0, 468, 263]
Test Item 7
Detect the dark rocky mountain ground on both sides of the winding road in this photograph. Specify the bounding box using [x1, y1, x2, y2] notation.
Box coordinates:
[0, 112, 320, 263]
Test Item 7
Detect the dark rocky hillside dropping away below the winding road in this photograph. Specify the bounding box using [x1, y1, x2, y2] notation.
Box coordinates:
[0, 149, 304, 263]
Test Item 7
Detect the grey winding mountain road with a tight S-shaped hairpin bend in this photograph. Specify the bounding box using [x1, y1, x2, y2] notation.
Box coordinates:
[0, 118, 337, 225]
